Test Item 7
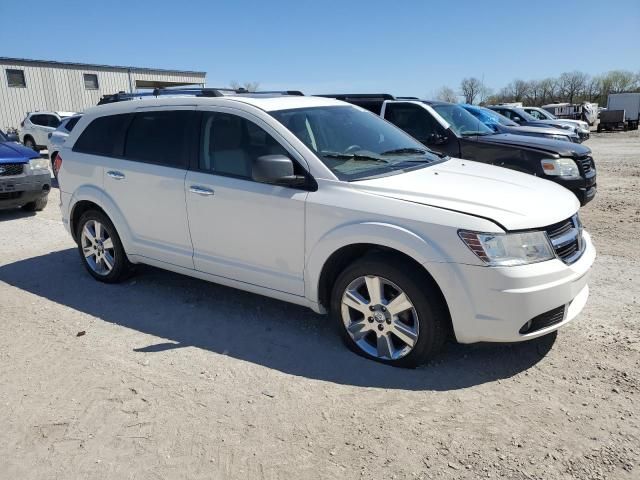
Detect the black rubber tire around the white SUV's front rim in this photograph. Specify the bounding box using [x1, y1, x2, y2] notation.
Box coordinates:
[330, 254, 450, 368]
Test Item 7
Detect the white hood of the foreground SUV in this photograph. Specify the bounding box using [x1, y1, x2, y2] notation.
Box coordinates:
[351, 158, 580, 230]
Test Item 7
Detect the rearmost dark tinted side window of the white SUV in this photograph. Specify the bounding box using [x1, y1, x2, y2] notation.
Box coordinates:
[73, 114, 131, 156]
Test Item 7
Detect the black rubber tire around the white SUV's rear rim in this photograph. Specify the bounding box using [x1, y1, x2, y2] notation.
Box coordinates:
[76, 210, 132, 283]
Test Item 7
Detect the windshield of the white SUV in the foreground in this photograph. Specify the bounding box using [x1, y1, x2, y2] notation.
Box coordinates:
[271, 105, 441, 181]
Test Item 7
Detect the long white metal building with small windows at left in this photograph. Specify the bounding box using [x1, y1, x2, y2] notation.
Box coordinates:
[0, 57, 206, 130]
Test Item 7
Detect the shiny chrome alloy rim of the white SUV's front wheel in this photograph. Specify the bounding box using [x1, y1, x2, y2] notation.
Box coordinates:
[341, 275, 420, 360]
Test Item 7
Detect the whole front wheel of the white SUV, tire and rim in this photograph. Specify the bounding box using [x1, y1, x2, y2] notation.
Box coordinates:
[331, 255, 448, 368]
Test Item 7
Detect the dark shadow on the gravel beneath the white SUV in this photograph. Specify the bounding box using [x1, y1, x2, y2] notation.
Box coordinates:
[0, 249, 556, 391]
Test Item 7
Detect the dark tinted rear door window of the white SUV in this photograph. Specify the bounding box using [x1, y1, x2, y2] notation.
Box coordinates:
[124, 110, 192, 167]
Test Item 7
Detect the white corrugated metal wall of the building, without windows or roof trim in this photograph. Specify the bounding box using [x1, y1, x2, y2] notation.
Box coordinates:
[0, 61, 205, 130]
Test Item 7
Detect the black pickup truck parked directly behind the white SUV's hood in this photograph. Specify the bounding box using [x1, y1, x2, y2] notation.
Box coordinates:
[320, 94, 597, 205]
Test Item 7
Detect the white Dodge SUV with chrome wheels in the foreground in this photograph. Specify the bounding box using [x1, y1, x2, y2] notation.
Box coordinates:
[57, 94, 595, 367]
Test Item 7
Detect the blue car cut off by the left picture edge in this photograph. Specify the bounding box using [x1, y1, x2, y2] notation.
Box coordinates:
[0, 131, 51, 211]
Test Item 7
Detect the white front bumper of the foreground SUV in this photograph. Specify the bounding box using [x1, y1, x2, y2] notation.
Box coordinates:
[425, 232, 596, 343]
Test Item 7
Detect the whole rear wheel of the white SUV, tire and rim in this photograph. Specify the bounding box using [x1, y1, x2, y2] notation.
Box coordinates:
[76, 210, 130, 283]
